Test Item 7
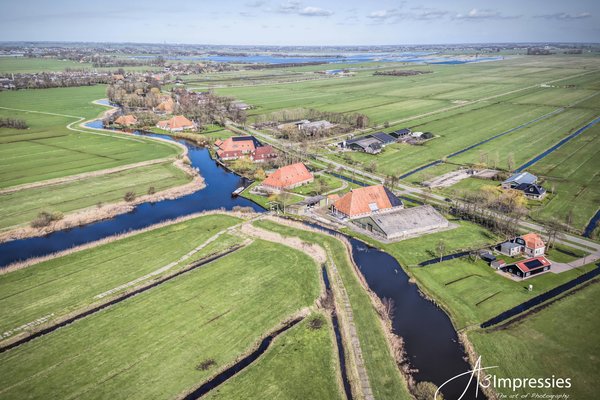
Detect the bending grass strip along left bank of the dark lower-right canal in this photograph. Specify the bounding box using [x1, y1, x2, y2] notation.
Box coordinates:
[254, 220, 411, 400]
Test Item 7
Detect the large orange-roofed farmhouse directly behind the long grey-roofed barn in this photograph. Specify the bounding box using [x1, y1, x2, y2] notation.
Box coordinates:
[331, 185, 404, 219]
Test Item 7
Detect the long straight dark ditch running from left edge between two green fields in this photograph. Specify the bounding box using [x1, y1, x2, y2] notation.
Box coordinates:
[0, 245, 244, 353]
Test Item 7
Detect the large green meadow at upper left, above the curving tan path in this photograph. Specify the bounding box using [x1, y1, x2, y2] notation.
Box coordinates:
[0, 86, 181, 188]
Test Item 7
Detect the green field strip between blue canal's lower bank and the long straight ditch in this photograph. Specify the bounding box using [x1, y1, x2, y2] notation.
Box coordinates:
[0, 215, 239, 332]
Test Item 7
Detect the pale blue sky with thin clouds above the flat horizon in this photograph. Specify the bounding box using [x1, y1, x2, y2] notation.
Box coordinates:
[0, 0, 600, 45]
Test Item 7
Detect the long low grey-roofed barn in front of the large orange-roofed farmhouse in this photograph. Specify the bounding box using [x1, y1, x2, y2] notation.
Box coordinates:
[353, 205, 449, 240]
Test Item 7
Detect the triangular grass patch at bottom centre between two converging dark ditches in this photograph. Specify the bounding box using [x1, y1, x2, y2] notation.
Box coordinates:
[206, 313, 343, 400]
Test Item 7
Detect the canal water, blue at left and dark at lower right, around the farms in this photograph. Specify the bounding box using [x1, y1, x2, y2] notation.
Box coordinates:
[0, 123, 484, 399]
